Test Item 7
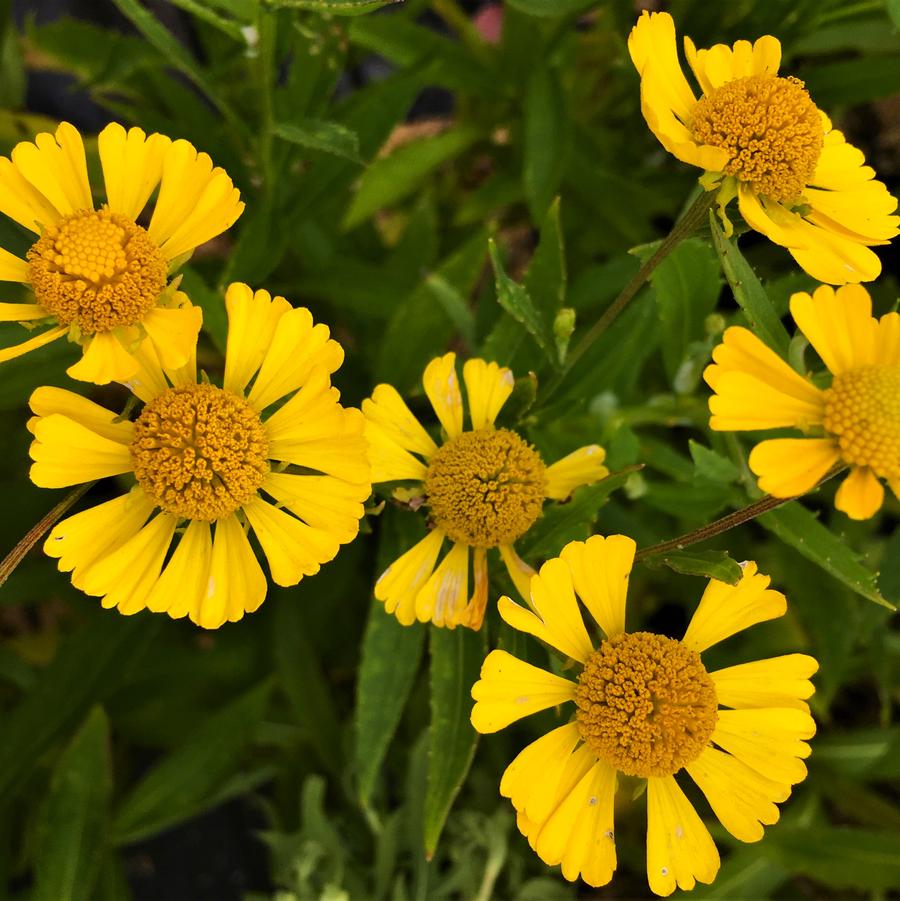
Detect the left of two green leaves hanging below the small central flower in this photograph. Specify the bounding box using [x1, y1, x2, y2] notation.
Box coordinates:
[354, 601, 425, 804]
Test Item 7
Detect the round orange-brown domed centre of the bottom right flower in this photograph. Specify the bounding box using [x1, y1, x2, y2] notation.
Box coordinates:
[575, 632, 718, 779]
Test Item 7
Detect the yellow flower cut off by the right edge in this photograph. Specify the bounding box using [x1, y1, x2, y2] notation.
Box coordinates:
[704, 285, 900, 519]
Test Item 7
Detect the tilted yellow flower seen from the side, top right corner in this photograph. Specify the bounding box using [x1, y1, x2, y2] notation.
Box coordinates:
[628, 12, 900, 285]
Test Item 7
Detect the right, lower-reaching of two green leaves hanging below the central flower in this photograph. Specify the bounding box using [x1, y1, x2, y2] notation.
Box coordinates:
[424, 627, 487, 859]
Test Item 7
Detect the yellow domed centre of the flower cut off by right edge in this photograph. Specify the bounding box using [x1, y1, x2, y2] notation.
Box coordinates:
[825, 366, 900, 479]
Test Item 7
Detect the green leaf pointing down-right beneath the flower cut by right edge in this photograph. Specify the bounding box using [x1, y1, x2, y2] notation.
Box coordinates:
[758, 502, 895, 610]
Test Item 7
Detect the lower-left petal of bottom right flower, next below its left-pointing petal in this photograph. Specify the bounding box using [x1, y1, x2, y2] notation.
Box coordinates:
[500, 723, 581, 823]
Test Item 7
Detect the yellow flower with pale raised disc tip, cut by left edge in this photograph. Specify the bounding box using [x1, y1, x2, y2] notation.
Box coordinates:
[0, 122, 244, 385]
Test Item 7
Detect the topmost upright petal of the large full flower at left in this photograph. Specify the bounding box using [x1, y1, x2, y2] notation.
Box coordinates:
[223, 282, 291, 394]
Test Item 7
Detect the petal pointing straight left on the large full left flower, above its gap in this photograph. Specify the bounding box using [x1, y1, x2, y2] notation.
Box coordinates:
[29, 413, 131, 488]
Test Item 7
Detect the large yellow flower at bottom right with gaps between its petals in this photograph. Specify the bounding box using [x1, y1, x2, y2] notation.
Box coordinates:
[472, 535, 818, 895]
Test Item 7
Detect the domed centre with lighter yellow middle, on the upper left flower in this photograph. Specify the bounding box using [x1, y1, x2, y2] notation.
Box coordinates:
[28, 209, 168, 335]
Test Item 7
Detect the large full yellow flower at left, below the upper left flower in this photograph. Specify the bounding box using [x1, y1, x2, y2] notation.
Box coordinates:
[29, 284, 371, 629]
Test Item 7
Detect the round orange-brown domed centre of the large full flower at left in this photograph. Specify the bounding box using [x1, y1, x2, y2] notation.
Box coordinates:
[131, 385, 269, 522]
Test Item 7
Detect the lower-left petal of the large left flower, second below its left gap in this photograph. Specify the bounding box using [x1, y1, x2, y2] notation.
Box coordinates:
[81, 513, 177, 615]
